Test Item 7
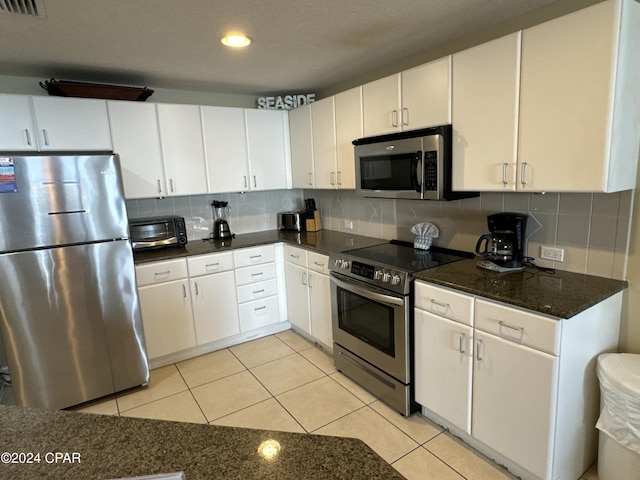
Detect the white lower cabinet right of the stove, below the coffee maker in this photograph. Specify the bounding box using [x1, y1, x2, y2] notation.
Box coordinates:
[414, 281, 622, 480]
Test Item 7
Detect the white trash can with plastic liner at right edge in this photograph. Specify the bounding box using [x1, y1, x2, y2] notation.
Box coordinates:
[596, 353, 640, 480]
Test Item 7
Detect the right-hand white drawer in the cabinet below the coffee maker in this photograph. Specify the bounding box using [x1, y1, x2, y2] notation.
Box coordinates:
[475, 300, 562, 355]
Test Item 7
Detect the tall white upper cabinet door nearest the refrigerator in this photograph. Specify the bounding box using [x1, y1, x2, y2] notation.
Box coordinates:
[107, 100, 167, 198]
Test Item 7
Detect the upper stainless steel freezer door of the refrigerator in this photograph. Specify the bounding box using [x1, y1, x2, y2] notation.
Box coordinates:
[0, 155, 128, 252]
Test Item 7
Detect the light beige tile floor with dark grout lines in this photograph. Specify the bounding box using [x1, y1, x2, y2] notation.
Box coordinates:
[78, 330, 597, 480]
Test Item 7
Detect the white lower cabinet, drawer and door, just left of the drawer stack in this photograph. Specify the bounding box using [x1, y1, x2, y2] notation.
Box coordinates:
[187, 252, 240, 345]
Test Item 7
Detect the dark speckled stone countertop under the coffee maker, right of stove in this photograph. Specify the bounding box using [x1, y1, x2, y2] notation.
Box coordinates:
[415, 258, 628, 318]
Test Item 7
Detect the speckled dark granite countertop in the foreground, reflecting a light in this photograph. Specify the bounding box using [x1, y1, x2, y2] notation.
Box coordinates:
[0, 406, 404, 480]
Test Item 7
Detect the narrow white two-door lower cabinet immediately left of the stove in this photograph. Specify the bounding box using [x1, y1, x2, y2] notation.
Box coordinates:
[284, 245, 333, 348]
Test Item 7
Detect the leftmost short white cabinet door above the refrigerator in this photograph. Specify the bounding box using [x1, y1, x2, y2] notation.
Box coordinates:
[0, 95, 38, 151]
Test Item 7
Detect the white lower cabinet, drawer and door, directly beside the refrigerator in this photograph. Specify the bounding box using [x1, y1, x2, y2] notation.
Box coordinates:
[136, 259, 196, 360]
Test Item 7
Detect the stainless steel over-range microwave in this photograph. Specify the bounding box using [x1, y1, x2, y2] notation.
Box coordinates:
[353, 125, 478, 200]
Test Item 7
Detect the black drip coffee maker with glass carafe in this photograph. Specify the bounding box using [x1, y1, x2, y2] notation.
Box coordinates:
[476, 213, 529, 272]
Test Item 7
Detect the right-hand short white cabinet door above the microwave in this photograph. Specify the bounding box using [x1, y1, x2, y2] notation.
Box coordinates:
[400, 56, 451, 130]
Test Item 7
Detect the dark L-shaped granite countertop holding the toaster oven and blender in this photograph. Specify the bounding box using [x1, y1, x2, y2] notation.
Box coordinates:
[134, 230, 388, 264]
